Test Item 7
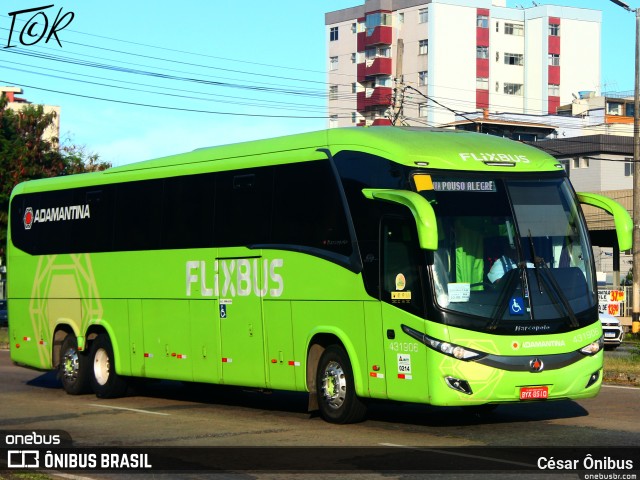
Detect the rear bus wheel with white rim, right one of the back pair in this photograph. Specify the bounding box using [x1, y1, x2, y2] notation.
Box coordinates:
[91, 334, 127, 398]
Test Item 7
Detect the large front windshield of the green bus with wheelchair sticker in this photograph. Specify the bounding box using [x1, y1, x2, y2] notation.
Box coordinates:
[422, 175, 596, 330]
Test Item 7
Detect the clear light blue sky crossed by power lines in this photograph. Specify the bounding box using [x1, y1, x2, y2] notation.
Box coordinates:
[0, 0, 640, 166]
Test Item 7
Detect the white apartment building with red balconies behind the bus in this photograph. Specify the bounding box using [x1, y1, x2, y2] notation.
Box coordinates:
[325, 0, 601, 127]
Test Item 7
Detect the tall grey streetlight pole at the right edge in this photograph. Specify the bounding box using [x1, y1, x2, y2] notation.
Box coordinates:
[611, 0, 640, 333]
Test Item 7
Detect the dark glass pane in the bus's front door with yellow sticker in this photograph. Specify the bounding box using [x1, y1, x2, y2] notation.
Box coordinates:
[381, 217, 424, 315]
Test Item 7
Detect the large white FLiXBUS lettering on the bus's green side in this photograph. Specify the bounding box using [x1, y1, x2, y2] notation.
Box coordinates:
[186, 258, 284, 297]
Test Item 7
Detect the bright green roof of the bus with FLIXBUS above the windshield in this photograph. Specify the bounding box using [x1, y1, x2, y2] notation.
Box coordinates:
[14, 127, 562, 193]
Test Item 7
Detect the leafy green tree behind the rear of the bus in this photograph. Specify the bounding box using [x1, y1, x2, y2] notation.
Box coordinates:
[0, 94, 111, 261]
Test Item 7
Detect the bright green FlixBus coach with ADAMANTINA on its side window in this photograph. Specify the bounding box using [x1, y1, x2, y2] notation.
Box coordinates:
[7, 127, 632, 423]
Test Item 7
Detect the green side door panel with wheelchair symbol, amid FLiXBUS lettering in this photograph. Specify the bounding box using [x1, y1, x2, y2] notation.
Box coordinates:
[217, 248, 266, 387]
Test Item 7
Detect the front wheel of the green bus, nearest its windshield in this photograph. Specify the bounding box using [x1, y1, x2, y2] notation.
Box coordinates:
[316, 345, 367, 424]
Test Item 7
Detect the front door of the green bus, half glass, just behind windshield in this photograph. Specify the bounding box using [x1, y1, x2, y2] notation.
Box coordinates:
[380, 216, 428, 402]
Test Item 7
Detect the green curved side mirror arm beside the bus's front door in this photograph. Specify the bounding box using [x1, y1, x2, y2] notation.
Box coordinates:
[362, 188, 438, 250]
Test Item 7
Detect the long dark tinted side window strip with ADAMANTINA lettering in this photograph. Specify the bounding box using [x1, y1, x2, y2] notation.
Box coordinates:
[11, 160, 352, 262]
